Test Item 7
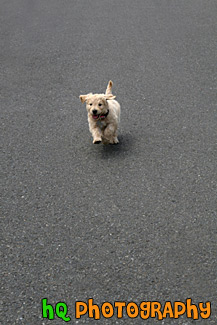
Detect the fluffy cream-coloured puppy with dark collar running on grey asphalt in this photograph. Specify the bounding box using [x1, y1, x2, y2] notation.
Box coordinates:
[80, 80, 121, 144]
